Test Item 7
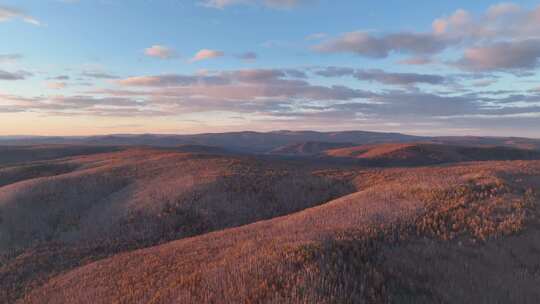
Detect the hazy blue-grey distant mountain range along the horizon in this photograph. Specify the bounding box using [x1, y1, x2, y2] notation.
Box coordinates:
[0, 131, 540, 155]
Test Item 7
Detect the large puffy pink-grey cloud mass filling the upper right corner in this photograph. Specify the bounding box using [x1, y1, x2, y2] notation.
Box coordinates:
[313, 3, 540, 74]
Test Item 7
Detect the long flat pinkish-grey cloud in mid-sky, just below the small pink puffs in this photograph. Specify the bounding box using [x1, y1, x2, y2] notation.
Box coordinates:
[109, 69, 367, 101]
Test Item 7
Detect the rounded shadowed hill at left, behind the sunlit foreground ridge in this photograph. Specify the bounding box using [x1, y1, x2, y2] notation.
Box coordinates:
[0, 146, 354, 299]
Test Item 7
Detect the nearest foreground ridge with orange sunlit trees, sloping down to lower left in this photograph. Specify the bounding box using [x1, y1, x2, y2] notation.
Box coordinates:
[16, 161, 540, 303]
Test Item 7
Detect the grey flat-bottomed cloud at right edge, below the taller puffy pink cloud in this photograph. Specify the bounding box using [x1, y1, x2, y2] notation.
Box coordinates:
[455, 39, 540, 71]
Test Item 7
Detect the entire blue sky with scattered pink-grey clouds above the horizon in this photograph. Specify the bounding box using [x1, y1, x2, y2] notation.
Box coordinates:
[0, 0, 540, 138]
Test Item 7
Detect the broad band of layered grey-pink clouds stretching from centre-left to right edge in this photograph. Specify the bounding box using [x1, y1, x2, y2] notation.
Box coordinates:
[106, 67, 539, 120]
